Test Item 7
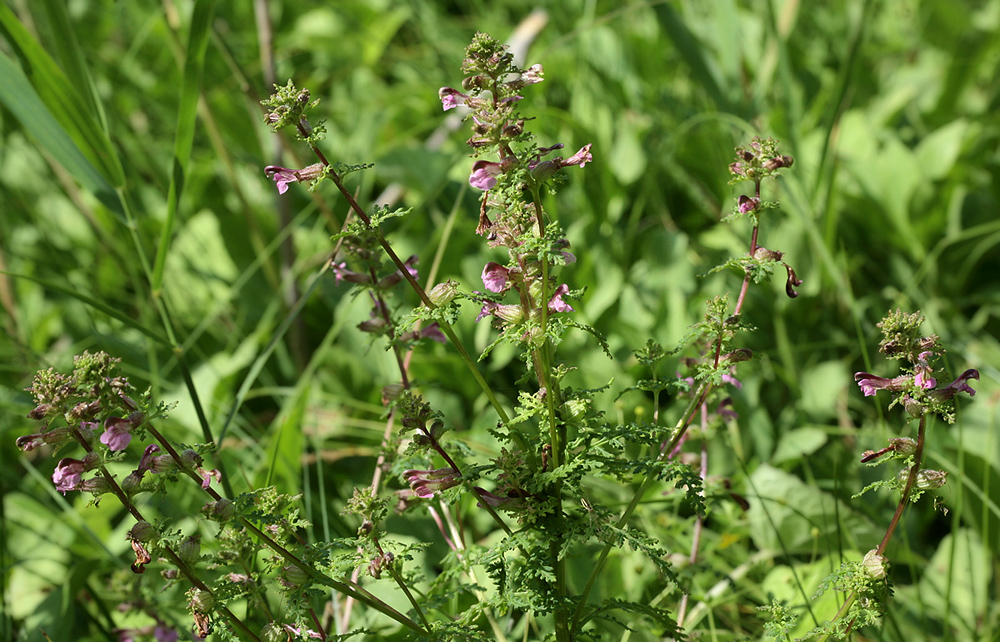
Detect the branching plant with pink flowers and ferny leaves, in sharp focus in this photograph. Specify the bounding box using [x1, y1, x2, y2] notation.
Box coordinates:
[18, 28, 978, 642]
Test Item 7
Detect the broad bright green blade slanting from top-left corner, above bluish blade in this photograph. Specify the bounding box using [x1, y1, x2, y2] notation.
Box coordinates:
[0, 4, 125, 188]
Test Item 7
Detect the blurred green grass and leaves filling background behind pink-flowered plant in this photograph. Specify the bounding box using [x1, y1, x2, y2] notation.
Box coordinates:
[0, 0, 1000, 640]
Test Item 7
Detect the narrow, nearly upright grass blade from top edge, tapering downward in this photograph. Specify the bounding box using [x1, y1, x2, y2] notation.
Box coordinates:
[152, 0, 215, 292]
